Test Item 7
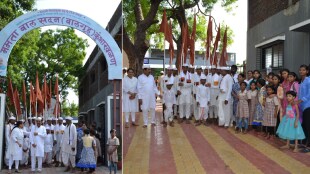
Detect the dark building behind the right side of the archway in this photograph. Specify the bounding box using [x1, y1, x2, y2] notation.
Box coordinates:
[79, 3, 122, 164]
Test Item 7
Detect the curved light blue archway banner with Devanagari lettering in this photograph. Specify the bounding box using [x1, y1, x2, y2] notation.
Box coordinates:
[0, 9, 122, 80]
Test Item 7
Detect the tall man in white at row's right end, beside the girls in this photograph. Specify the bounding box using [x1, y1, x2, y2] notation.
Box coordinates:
[218, 67, 233, 128]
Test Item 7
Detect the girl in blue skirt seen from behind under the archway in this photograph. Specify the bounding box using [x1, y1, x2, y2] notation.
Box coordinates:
[76, 129, 96, 173]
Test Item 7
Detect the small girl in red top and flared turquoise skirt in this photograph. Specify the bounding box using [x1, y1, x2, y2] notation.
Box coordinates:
[277, 91, 305, 152]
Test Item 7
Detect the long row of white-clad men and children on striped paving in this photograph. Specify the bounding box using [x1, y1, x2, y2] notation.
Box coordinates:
[123, 64, 310, 152]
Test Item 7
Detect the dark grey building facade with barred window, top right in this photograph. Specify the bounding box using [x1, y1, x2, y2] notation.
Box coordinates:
[246, 0, 310, 72]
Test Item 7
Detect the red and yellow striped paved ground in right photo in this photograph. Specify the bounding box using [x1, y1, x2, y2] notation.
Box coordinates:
[123, 102, 310, 174]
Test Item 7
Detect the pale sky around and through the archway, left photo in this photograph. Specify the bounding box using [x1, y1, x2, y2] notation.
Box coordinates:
[35, 0, 121, 104]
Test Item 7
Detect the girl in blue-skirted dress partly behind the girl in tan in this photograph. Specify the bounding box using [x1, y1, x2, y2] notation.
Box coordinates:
[253, 79, 267, 133]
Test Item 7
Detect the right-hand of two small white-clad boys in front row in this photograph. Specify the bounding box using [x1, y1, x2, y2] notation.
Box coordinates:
[195, 75, 210, 126]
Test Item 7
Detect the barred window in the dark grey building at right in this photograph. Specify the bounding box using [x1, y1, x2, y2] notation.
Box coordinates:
[262, 42, 284, 69]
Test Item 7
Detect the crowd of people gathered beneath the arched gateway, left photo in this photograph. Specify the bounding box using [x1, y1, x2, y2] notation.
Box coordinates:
[5, 116, 114, 173]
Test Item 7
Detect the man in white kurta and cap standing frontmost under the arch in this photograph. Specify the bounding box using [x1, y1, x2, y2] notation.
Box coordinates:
[30, 117, 46, 172]
